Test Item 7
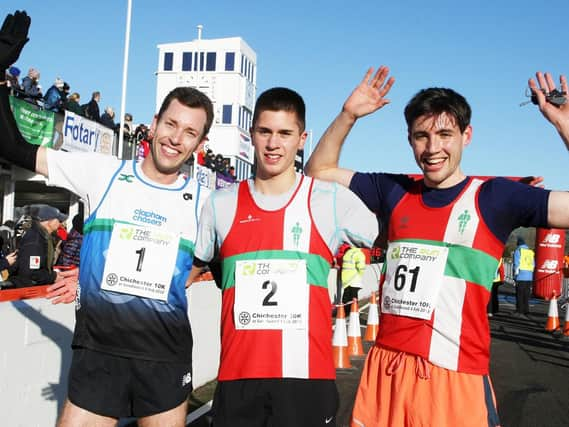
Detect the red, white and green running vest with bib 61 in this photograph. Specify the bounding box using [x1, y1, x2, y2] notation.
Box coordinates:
[376, 179, 504, 374]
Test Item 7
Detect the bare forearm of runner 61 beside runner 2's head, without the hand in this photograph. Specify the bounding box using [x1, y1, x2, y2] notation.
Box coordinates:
[304, 111, 356, 187]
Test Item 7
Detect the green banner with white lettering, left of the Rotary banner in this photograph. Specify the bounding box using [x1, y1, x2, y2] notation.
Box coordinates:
[10, 96, 55, 147]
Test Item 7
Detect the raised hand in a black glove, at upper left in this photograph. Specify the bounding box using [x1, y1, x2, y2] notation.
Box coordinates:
[0, 10, 31, 71]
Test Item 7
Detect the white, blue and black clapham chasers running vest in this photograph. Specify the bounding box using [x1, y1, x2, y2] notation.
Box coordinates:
[73, 161, 201, 362]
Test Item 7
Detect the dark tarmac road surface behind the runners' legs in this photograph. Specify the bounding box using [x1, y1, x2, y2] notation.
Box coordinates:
[188, 285, 569, 427]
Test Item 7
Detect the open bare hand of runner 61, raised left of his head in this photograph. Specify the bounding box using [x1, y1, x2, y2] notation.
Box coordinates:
[343, 65, 395, 119]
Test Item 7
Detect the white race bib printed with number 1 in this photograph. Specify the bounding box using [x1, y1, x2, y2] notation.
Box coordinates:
[101, 223, 180, 301]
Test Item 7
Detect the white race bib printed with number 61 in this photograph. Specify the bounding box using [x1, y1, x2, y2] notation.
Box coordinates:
[381, 242, 448, 319]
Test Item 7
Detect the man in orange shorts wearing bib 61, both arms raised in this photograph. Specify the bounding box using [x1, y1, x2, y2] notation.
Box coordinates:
[306, 67, 569, 427]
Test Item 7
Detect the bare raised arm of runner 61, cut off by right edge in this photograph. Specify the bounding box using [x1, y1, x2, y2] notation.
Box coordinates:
[528, 71, 569, 228]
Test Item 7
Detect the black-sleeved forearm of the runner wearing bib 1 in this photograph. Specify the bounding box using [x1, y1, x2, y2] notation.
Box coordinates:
[0, 85, 39, 172]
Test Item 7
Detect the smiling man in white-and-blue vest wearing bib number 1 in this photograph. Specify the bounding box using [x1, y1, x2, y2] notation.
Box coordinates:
[0, 12, 213, 426]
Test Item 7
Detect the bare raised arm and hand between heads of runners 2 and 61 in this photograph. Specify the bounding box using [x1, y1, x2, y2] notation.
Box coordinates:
[304, 66, 395, 187]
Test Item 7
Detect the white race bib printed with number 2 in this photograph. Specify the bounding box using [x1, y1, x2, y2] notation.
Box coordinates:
[233, 259, 309, 329]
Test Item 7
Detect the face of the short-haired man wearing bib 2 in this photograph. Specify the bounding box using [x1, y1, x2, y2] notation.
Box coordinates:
[251, 110, 307, 182]
